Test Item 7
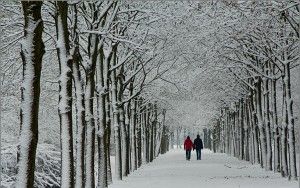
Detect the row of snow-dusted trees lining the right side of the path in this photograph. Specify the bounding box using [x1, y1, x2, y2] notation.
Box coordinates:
[207, 1, 300, 179]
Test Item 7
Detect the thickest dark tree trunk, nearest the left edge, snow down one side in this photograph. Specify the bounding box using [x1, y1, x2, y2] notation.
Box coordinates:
[17, 1, 45, 188]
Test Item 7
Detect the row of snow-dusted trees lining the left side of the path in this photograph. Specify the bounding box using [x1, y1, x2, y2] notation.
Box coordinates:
[17, 0, 169, 188]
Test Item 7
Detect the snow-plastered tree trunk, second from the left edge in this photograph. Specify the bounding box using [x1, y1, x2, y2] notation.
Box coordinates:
[56, 1, 74, 187]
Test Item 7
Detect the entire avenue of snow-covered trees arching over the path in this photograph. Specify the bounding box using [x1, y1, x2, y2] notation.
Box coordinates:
[0, 0, 300, 188]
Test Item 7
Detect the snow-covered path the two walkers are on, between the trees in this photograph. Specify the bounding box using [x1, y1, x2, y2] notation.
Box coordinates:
[109, 150, 298, 188]
